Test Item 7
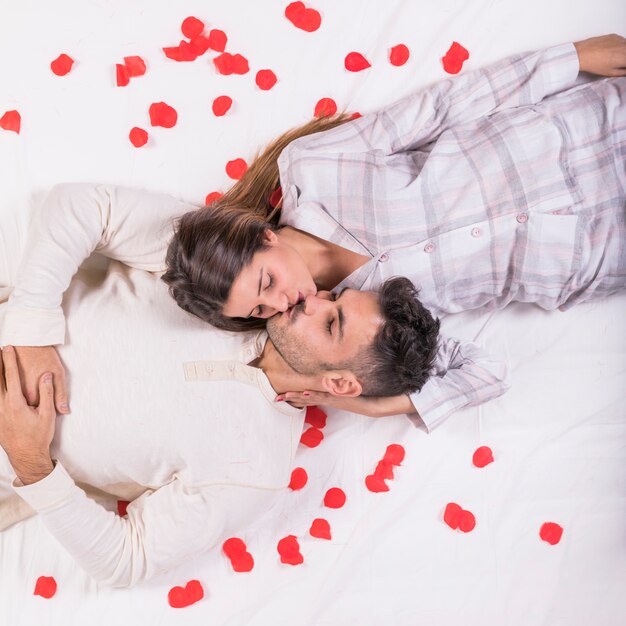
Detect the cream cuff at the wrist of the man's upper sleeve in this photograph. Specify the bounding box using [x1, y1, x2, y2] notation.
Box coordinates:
[0, 303, 65, 346]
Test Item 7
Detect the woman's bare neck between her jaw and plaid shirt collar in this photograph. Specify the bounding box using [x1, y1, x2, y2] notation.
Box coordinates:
[278, 226, 369, 290]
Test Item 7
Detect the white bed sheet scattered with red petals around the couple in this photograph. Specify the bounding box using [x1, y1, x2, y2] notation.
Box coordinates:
[0, 0, 626, 626]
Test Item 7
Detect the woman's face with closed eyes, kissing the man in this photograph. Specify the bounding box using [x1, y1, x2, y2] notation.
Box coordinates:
[224, 230, 317, 318]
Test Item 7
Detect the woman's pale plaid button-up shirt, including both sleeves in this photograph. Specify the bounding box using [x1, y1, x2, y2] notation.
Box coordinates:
[279, 44, 626, 429]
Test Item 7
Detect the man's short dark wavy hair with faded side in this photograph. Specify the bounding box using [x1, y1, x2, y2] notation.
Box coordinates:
[346, 277, 439, 396]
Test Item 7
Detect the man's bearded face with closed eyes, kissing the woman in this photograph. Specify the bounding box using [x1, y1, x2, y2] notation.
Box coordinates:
[267, 289, 383, 374]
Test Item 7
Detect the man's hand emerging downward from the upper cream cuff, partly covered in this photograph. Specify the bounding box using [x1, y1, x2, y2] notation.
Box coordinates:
[15, 346, 70, 414]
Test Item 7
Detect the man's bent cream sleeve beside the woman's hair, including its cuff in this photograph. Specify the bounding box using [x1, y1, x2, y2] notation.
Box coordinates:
[0, 184, 197, 346]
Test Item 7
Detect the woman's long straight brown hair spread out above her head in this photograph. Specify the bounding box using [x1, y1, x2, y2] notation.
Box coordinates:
[162, 113, 352, 331]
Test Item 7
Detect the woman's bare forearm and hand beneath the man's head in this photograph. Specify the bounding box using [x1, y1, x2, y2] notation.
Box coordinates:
[276, 391, 416, 417]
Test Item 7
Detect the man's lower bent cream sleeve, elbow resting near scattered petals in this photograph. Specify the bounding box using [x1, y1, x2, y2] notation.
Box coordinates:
[13, 461, 276, 587]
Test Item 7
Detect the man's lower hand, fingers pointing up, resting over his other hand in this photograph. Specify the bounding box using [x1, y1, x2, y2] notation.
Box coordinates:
[0, 346, 56, 485]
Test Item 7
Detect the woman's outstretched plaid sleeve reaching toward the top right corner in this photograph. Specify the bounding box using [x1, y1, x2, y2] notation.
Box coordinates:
[279, 43, 579, 158]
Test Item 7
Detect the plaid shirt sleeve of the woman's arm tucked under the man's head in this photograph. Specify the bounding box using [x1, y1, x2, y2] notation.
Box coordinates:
[409, 339, 510, 432]
